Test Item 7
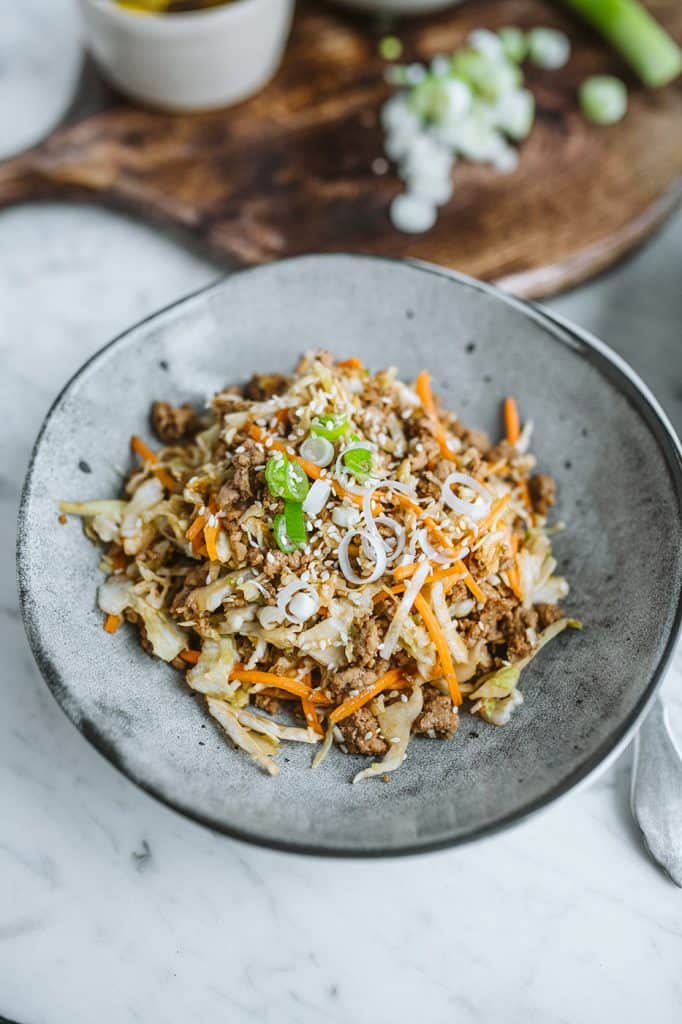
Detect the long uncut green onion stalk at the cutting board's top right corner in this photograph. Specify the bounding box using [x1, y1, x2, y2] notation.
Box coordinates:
[563, 0, 682, 87]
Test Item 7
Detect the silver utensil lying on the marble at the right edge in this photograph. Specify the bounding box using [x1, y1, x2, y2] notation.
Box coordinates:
[630, 697, 682, 888]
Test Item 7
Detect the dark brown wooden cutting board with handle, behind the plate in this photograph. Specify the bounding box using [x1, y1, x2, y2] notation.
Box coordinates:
[0, 0, 682, 297]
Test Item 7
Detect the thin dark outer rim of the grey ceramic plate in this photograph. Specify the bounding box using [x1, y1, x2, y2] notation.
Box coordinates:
[16, 252, 682, 859]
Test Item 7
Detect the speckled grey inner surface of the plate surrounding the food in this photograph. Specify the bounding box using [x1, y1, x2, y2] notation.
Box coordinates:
[18, 256, 682, 855]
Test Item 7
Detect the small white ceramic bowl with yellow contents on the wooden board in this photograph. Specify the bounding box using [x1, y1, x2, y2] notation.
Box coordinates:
[80, 0, 294, 111]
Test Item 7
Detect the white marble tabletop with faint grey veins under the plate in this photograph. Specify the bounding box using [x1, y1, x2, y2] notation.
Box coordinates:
[0, 0, 682, 1024]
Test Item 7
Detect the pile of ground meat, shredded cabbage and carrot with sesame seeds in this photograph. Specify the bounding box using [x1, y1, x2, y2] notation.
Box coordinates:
[61, 351, 579, 781]
